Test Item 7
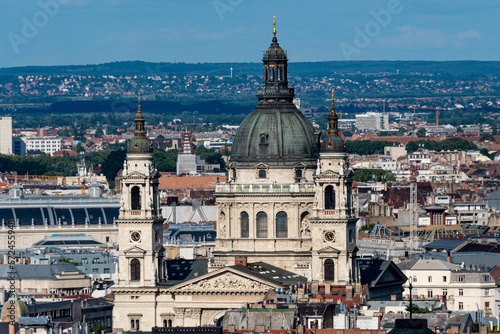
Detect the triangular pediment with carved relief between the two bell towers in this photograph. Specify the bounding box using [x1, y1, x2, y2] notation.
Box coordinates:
[171, 267, 281, 292]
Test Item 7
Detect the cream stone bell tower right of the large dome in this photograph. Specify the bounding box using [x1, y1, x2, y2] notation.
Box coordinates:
[310, 91, 357, 285]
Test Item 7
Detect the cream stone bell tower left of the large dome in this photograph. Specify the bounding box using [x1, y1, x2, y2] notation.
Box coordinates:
[117, 96, 164, 287]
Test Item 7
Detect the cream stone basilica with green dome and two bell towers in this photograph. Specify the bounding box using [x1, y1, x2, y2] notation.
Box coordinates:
[113, 23, 358, 330]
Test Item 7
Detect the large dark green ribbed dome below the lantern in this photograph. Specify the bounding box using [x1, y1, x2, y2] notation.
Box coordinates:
[231, 103, 319, 167]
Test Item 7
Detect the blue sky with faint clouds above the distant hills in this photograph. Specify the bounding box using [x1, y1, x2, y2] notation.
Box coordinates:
[0, 0, 500, 67]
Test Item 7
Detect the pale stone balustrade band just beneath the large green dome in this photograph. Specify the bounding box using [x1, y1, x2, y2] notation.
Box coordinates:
[215, 182, 314, 194]
